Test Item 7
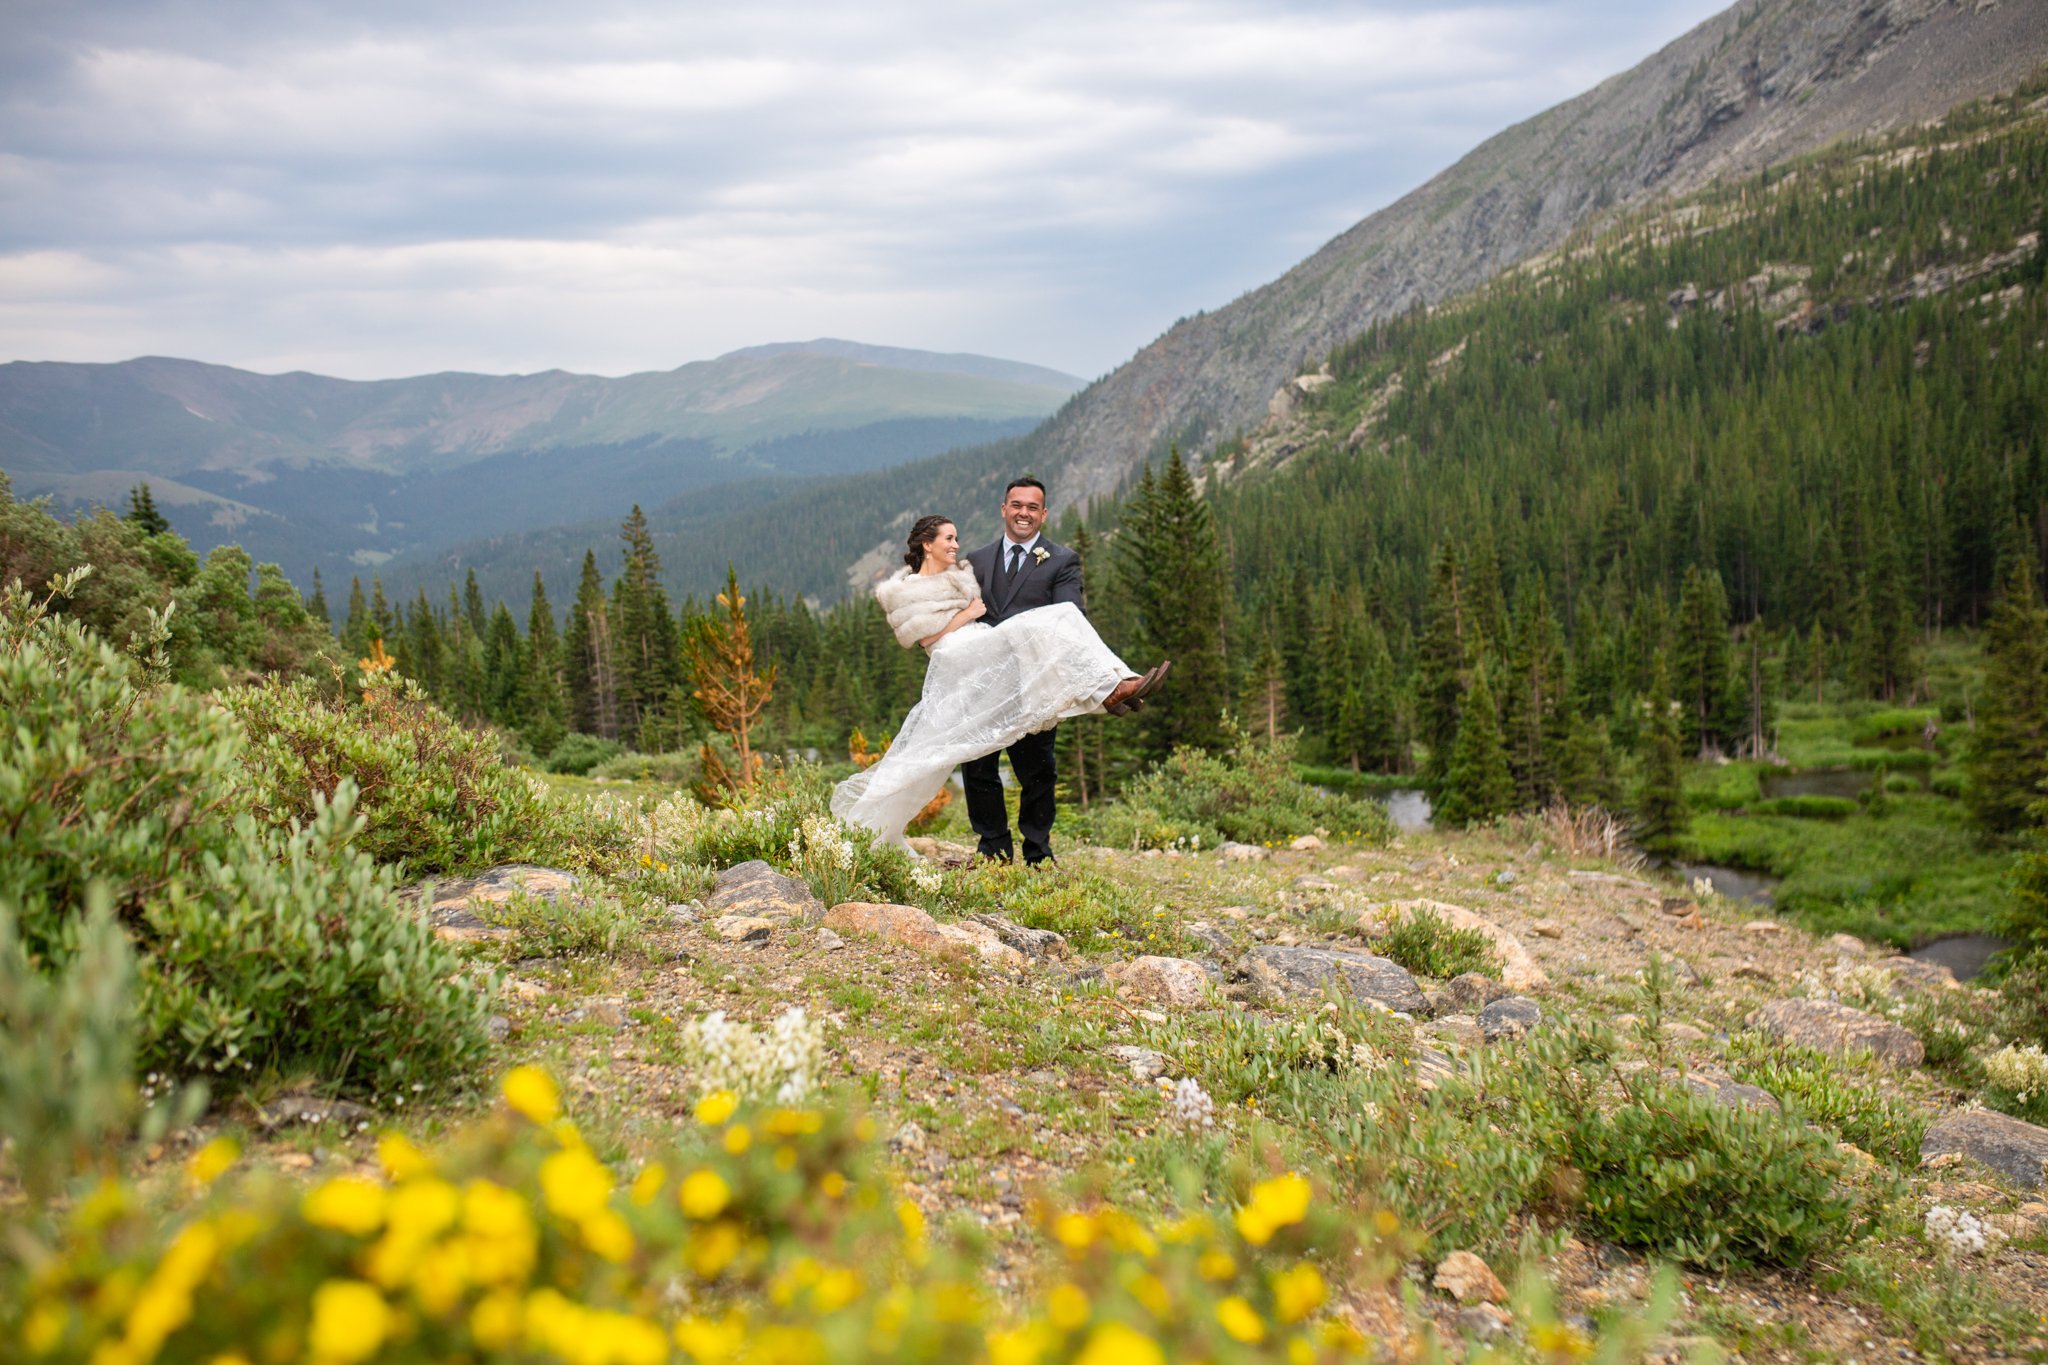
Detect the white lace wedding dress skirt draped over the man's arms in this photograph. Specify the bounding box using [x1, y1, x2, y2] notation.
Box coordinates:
[831, 602, 1137, 843]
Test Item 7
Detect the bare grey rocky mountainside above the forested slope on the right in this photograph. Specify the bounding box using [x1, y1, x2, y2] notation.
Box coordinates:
[1034, 0, 2048, 503]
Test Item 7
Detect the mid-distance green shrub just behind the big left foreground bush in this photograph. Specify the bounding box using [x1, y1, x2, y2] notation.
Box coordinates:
[221, 673, 616, 876]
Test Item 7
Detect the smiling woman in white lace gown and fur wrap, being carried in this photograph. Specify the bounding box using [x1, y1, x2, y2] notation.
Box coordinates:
[831, 516, 1167, 843]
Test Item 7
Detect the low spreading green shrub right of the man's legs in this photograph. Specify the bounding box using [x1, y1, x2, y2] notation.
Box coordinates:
[1087, 724, 1393, 847]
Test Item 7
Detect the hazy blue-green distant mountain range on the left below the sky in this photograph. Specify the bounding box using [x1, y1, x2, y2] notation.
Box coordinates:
[0, 340, 1081, 587]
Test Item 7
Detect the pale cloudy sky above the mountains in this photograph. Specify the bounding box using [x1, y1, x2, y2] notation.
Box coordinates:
[0, 0, 1722, 379]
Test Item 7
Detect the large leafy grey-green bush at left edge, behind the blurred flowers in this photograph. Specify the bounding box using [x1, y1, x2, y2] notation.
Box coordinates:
[0, 587, 487, 1095]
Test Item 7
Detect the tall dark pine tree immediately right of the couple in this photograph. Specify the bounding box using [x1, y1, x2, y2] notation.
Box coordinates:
[1116, 456, 1231, 757]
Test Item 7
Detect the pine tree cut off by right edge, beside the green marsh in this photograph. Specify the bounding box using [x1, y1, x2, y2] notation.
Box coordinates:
[1968, 557, 2048, 835]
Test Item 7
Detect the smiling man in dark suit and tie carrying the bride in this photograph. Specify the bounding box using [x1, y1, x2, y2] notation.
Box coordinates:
[961, 479, 1087, 868]
